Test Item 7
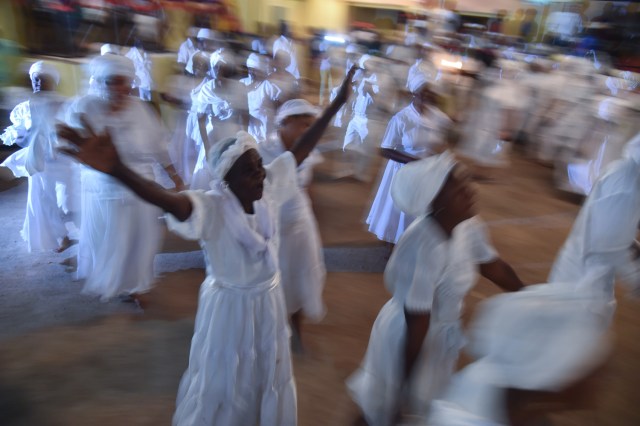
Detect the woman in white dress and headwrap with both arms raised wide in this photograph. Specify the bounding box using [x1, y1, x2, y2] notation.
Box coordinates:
[59, 65, 355, 426]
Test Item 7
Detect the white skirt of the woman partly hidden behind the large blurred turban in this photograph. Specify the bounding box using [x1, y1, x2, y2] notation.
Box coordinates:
[367, 160, 414, 244]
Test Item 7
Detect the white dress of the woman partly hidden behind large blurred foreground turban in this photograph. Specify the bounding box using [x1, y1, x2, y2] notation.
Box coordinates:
[367, 104, 451, 244]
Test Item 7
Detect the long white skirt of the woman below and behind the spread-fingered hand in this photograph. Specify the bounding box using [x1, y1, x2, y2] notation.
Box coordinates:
[78, 171, 162, 300]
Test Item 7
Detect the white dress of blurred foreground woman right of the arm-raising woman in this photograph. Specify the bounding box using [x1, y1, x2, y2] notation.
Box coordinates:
[347, 216, 496, 426]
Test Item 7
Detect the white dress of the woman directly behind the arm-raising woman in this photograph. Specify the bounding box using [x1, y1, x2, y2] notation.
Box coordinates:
[260, 135, 326, 321]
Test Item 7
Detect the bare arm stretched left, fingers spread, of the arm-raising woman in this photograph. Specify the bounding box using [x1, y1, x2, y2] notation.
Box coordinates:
[57, 116, 193, 221]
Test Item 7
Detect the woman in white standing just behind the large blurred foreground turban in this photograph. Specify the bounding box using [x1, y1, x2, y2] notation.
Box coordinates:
[367, 72, 451, 244]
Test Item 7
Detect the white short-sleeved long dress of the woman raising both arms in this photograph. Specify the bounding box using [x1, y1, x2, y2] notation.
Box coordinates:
[167, 153, 296, 426]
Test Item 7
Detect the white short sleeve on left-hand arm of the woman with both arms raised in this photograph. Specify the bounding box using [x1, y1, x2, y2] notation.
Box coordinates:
[165, 191, 218, 240]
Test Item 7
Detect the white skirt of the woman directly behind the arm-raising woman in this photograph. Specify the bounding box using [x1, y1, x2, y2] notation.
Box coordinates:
[278, 192, 326, 322]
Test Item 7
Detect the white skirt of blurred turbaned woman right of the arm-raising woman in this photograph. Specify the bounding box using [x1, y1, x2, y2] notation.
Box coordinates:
[347, 299, 464, 426]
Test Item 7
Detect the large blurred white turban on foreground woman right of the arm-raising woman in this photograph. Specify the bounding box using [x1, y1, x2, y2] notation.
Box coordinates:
[391, 151, 456, 217]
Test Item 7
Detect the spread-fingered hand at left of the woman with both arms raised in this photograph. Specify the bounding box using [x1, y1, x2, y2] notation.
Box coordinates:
[56, 114, 122, 175]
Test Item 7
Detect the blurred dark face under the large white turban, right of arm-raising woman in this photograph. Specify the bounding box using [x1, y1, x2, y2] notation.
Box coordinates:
[433, 164, 476, 223]
